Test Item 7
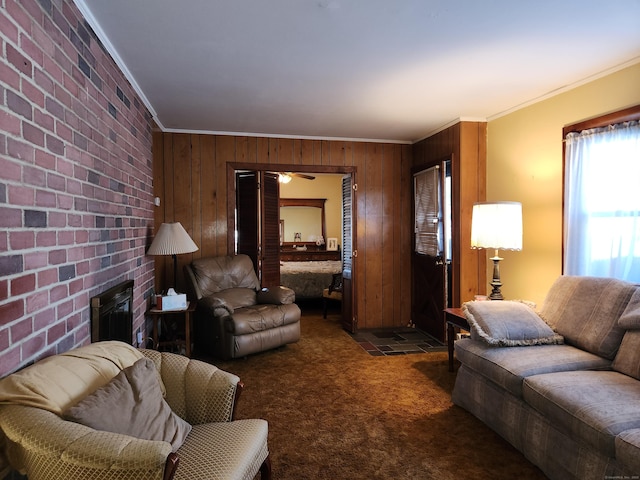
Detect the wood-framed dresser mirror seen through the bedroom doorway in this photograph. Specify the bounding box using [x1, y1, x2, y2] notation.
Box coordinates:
[280, 198, 327, 249]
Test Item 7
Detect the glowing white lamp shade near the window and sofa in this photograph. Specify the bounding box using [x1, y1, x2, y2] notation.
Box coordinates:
[471, 202, 522, 250]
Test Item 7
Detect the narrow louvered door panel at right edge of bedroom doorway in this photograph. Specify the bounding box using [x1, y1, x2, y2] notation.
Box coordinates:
[342, 175, 358, 333]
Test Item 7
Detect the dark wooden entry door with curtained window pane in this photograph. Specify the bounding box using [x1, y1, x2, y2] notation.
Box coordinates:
[411, 162, 448, 341]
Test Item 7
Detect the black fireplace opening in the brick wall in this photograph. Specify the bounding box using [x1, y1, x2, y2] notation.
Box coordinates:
[91, 280, 133, 344]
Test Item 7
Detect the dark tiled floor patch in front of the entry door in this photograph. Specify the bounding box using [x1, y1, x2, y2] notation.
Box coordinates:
[350, 327, 447, 356]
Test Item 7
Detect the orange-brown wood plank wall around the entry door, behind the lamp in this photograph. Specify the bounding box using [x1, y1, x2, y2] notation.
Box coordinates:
[413, 122, 493, 306]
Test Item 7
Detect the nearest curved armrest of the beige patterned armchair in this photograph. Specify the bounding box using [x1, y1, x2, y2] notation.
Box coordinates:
[0, 405, 171, 480]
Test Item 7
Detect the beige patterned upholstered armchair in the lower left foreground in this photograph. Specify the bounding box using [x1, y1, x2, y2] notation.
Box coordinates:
[0, 342, 271, 480]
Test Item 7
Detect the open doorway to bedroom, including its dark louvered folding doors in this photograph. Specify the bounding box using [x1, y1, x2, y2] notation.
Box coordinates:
[228, 164, 355, 331]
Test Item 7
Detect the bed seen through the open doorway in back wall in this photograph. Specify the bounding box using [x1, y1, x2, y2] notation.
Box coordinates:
[280, 260, 342, 300]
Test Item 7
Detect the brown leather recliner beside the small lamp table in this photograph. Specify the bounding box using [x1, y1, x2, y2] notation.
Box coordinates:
[184, 255, 300, 359]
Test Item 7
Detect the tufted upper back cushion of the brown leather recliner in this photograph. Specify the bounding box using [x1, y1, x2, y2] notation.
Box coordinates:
[191, 255, 260, 297]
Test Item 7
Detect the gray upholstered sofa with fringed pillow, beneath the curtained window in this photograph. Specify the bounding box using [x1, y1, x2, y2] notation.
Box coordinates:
[452, 276, 640, 480]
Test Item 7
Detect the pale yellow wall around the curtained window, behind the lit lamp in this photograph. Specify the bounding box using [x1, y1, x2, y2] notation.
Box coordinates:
[486, 64, 640, 305]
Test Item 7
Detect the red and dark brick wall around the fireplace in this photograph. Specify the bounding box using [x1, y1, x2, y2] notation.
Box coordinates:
[0, 0, 153, 377]
